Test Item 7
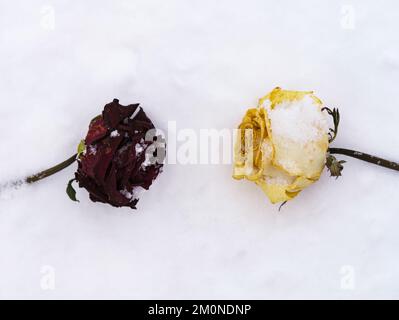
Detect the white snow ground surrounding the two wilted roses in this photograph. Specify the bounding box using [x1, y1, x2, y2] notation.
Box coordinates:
[0, 0, 399, 299]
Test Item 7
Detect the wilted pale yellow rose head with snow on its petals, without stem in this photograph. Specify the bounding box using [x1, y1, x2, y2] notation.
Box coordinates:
[233, 88, 329, 203]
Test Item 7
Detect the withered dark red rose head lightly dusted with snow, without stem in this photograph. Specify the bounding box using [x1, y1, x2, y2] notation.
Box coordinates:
[75, 99, 164, 209]
